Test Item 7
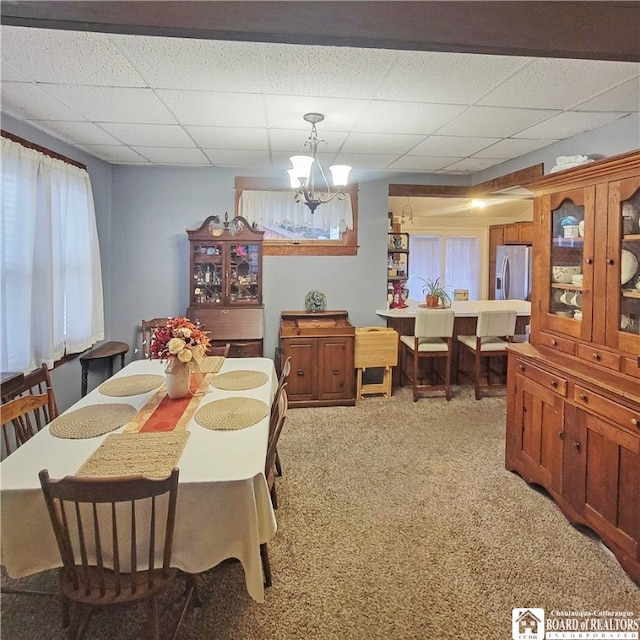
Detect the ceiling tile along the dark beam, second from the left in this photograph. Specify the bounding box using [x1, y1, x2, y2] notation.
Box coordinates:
[111, 35, 263, 93]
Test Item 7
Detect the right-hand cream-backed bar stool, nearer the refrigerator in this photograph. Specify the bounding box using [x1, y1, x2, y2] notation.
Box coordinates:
[458, 309, 516, 400]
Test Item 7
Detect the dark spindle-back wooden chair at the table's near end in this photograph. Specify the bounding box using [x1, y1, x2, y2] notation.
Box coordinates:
[39, 469, 200, 640]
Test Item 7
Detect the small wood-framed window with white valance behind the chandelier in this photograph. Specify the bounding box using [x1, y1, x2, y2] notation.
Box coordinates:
[235, 178, 358, 255]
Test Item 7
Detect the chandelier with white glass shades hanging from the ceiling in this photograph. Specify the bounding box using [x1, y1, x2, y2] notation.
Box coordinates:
[287, 113, 351, 213]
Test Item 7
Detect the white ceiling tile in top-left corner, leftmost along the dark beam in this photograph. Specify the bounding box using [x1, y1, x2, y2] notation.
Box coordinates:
[2, 26, 144, 87]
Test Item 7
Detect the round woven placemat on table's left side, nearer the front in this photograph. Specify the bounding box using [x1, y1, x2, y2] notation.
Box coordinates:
[49, 403, 136, 439]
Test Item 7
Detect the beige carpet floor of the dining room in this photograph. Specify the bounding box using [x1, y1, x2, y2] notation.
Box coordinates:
[1, 388, 640, 640]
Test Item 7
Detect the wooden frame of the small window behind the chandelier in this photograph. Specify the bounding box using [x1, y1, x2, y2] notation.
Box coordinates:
[234, 176, 358, 256]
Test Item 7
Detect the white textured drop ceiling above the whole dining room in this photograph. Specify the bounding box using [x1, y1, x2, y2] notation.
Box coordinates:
[1, 2, 640, 180]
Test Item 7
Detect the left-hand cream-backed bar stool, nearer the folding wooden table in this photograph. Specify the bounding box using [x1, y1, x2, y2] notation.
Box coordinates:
[400, 309, 455, 402]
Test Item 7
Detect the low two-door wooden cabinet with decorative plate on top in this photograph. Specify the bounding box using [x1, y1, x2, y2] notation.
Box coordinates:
[280, 311, 356, 407]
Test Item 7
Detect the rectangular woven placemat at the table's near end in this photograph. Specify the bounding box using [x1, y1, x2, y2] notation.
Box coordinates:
[76, 431, 189, 478]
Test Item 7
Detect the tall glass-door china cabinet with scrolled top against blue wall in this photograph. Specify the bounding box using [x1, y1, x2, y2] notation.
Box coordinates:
[187, 214, 264, 357]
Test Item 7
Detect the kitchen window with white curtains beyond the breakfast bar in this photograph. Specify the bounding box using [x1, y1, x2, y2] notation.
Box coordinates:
[409, 235, 480, 300]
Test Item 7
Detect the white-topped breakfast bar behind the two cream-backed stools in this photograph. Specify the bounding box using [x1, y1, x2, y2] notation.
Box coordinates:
[376, 300, 531, 386]
